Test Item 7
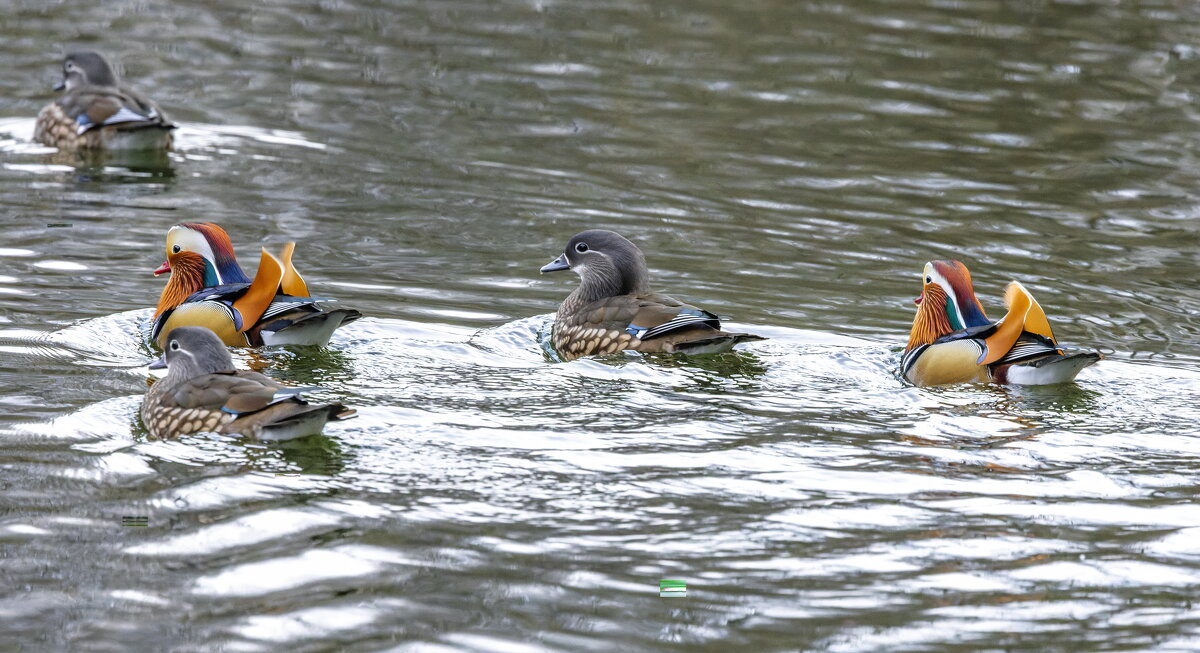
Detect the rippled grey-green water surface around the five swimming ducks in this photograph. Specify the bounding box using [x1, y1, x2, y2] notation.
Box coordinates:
[0, 0, 1200, 653]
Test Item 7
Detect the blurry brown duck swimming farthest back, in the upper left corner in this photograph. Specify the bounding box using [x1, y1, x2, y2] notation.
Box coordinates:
[34, 50, 175, 151]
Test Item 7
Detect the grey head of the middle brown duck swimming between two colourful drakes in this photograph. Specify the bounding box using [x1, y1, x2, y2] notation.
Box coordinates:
[541, 229, 649, 301]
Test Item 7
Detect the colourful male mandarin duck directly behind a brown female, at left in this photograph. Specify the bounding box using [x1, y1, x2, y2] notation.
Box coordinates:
[151, 222, 362, 349]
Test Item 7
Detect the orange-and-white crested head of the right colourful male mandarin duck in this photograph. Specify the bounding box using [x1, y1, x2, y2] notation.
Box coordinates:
[906, 260, 990, 349]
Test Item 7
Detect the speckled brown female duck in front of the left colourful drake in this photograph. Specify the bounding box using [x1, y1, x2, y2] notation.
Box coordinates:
[142, 327, 354, 439]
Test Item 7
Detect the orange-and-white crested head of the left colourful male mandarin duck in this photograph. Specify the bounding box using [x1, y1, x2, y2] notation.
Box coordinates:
[154, 222, 250, 317]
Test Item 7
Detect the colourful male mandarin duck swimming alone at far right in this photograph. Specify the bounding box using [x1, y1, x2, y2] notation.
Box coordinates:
[901, 260, 1100, 385]
